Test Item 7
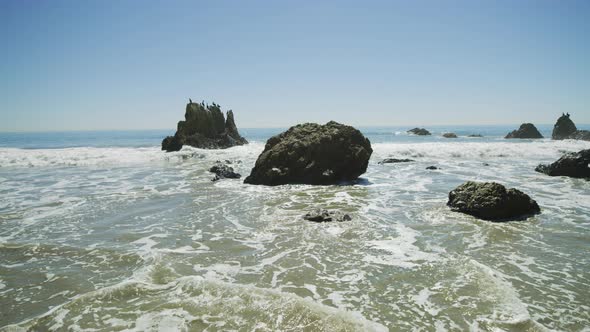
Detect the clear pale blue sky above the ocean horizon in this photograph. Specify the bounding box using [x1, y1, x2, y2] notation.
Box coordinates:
[0, 0, 590, 131]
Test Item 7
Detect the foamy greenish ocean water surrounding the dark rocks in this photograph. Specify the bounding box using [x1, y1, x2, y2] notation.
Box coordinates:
[0, 126, 590, 331]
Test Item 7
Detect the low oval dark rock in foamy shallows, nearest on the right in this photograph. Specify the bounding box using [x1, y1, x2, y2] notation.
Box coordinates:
[447, 181, 541, 221]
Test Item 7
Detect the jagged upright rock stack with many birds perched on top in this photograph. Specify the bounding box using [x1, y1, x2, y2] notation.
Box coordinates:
[162, 102, 248, 152]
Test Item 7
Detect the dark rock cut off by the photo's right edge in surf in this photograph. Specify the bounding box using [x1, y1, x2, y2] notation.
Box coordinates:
[535, 149, 590, 178]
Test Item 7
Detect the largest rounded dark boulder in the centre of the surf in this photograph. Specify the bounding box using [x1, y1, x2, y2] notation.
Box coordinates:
[244, 121, 373, 186]
